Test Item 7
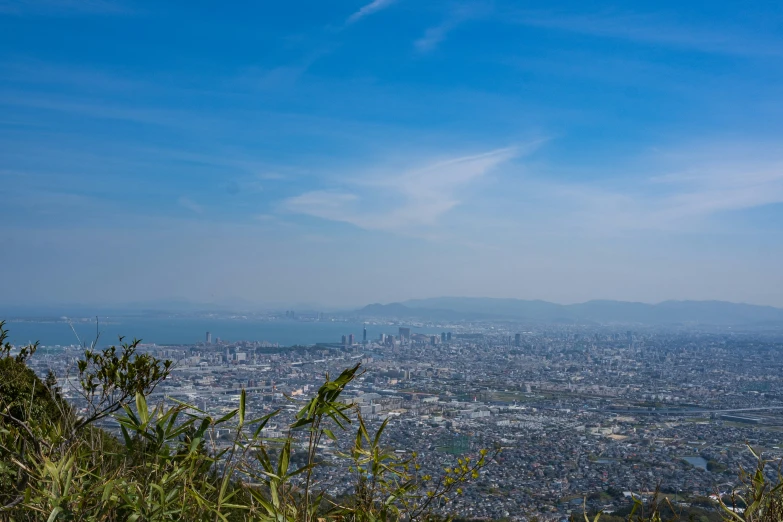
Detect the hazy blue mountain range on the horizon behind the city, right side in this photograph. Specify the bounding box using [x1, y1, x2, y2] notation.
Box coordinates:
[357, 297, 783, 325]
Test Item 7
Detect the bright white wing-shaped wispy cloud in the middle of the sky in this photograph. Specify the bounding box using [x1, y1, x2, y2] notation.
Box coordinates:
[282, 147, 524, 233]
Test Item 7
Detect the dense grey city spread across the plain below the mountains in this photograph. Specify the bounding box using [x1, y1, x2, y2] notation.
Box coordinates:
[10, 312, 783, 520]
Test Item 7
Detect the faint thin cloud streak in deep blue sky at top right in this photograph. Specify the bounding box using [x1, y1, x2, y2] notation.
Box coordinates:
[507, 11, 783, 56]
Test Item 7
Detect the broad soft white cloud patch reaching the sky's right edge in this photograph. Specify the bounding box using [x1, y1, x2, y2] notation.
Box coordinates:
[527, 147, 783, 235]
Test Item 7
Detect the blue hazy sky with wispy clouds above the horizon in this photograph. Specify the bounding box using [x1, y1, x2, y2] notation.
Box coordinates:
[0, 0, 783, 306]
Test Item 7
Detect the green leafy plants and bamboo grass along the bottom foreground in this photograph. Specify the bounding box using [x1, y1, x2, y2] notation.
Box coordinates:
[0, 316, 783, 522]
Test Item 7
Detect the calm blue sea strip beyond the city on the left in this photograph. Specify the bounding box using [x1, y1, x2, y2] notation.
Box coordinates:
[5, 317, 428, 347]
